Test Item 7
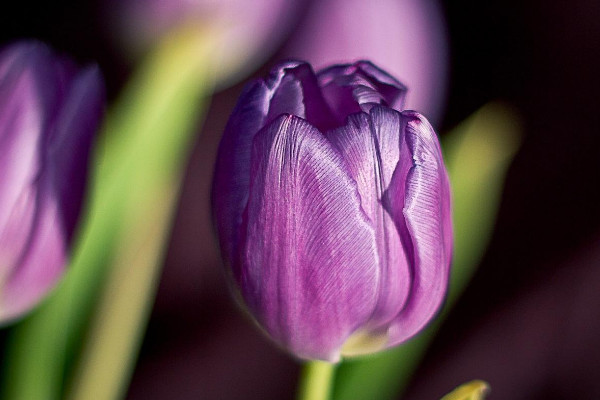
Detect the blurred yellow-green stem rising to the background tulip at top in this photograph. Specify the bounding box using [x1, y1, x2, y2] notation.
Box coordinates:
[66, 25, 212, 400]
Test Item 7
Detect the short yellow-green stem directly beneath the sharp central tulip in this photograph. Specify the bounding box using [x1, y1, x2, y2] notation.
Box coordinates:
[298, 361, 337, 400]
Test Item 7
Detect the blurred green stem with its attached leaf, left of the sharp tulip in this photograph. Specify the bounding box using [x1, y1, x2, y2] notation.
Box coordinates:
[4, 24, 217, 400]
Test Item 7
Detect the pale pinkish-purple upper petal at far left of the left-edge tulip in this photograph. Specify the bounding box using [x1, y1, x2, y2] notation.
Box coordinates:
[0, 41, 77, 256]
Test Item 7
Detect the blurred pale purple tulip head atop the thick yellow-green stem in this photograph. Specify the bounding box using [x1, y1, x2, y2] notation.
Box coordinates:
[108, 0, 304, 85]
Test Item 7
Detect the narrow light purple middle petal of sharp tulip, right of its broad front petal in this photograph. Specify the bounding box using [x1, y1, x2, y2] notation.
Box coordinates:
[327, 106, 411, 330]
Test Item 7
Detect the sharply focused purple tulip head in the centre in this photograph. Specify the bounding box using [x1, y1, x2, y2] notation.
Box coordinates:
[213, 62, 452, 361]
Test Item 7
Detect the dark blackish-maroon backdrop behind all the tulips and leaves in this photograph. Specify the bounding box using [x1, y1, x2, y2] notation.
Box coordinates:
[0, 0, 600, 399]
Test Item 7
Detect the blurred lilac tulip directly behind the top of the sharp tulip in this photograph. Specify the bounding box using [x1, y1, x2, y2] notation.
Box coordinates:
[283, 0, 448, 125]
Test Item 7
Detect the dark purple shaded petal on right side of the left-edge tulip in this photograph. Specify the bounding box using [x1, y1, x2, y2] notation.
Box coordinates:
[47, 66, 104, 241]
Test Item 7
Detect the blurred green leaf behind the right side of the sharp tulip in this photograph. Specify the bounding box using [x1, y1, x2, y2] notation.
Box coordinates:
[333, 103, 520, 400]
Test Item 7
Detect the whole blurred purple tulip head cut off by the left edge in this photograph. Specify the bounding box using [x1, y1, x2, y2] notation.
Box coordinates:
[0, 42, 104, 322]
